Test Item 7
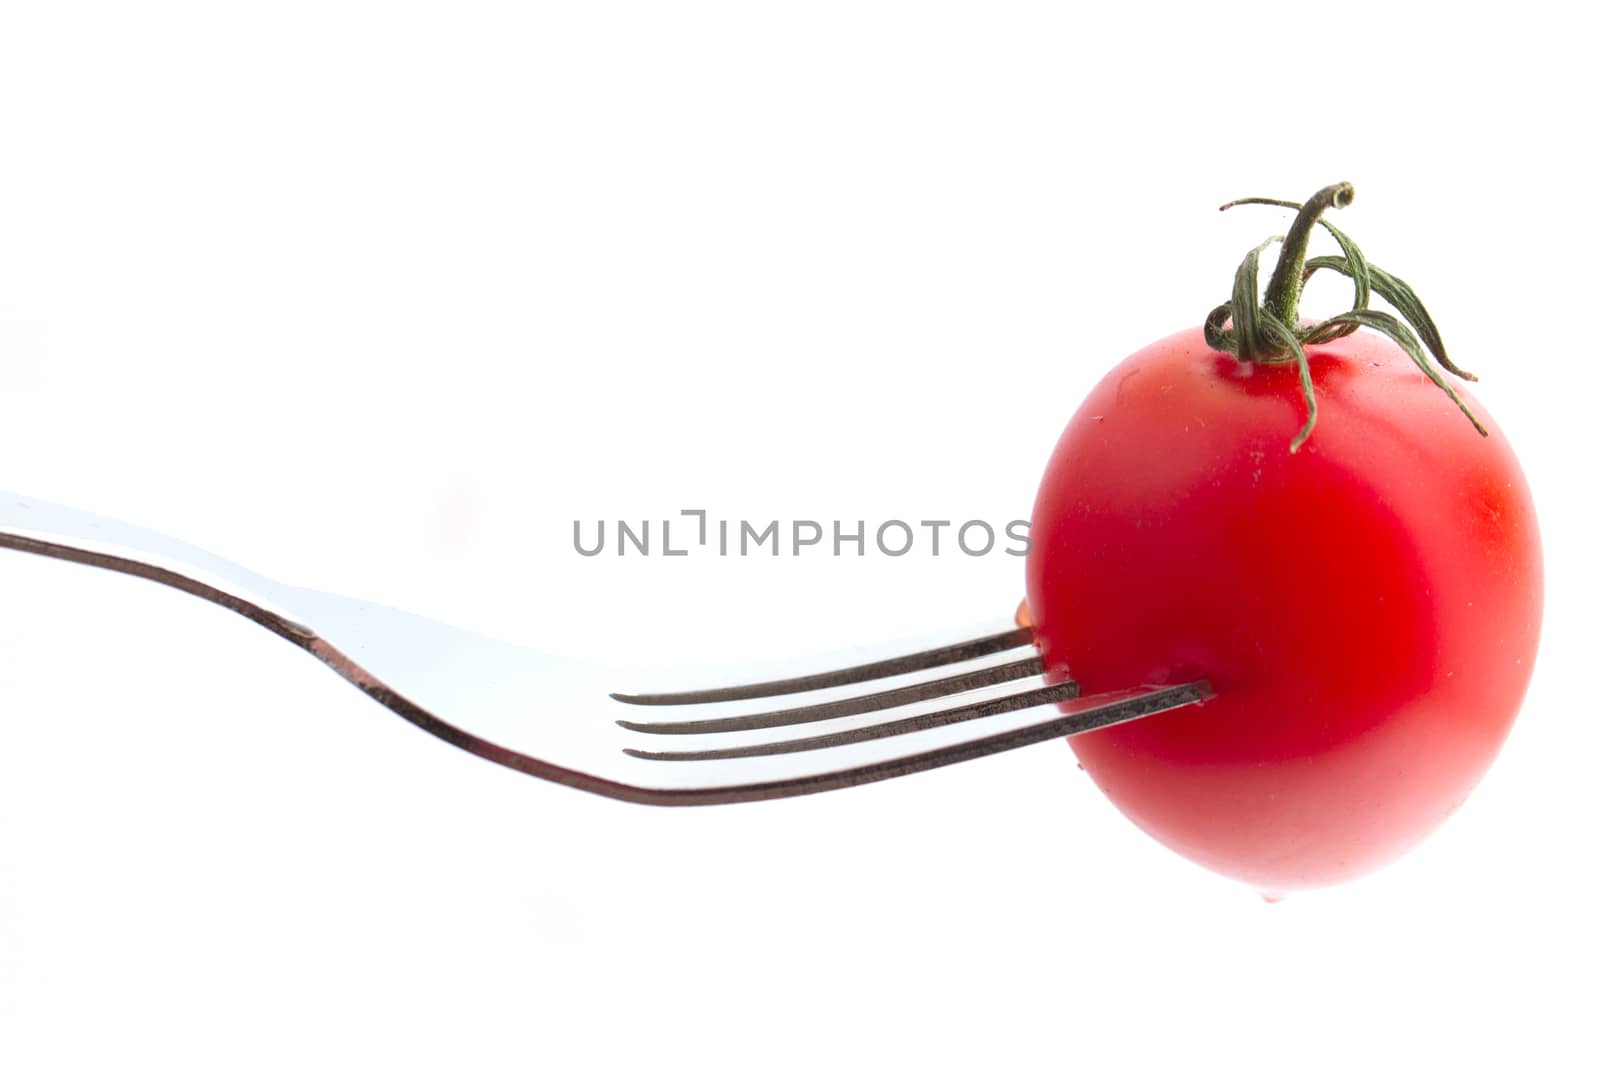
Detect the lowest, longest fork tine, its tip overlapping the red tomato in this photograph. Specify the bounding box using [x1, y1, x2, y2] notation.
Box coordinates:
[627, 681, 1211, 806]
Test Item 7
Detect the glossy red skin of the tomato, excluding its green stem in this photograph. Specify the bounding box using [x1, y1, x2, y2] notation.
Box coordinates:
[1027, 330, 1544, 893]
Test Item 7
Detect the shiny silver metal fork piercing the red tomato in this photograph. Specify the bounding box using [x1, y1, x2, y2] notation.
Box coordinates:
[0, 491, 1211, 806]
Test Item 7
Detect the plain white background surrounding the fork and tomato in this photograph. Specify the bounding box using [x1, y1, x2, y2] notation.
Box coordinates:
[0, 2, 1600, 1065]
